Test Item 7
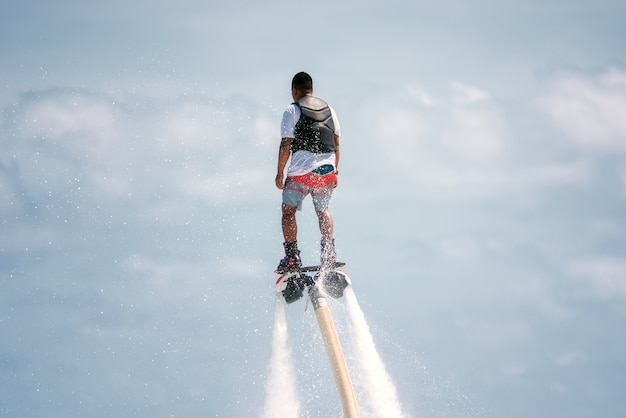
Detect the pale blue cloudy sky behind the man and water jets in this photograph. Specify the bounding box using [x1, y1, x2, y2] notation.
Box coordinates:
[0, 0, 626, 417]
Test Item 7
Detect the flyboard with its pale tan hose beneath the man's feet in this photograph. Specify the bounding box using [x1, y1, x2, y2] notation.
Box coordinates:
[275, 262, 360, 418]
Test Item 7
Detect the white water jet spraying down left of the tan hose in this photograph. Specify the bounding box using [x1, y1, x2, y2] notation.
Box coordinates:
[261, 296, 300, 418]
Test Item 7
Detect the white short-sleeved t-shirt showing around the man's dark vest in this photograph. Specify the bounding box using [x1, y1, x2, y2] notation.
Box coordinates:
[280, 103, 341, 177]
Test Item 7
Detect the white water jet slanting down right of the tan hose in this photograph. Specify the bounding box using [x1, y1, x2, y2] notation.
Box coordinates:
[344, 286, 405, 418]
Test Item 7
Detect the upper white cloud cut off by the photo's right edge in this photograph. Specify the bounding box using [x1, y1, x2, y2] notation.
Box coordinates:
[537, 70, 626, 152]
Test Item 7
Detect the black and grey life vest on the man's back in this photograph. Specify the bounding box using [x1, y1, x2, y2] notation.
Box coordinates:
[291, 96, 335, 154]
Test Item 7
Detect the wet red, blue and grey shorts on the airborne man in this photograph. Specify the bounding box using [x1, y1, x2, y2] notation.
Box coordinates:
[283, 166, 337, 212]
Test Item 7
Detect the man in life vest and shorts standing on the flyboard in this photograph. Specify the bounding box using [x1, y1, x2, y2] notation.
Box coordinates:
[276, 72, 341, 271]
